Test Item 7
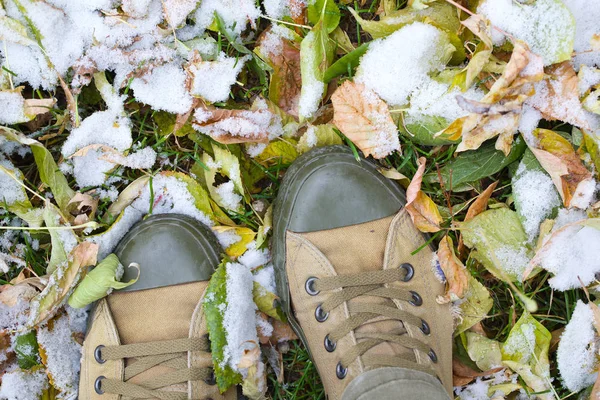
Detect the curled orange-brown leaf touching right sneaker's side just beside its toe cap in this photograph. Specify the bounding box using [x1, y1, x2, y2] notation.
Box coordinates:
[405, 157, 442, 232]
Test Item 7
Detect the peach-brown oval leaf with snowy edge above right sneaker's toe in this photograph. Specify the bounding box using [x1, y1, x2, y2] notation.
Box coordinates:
[331, 81, 400, 158]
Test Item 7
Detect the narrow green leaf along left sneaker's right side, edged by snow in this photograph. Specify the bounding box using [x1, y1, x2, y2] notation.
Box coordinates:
[203, 263, 242, 393]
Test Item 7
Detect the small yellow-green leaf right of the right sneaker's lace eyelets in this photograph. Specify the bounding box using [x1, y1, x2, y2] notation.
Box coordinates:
[454, 274, 494, 336]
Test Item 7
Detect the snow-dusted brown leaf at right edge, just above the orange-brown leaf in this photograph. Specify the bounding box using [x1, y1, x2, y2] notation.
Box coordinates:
[526, 61, 590, 129]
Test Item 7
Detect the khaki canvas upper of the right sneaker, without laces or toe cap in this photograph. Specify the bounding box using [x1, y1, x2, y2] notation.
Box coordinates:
[286, 210, 453, 400]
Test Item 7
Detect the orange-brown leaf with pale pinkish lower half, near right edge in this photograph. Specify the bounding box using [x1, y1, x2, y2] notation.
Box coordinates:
[530, 129, 593, 207]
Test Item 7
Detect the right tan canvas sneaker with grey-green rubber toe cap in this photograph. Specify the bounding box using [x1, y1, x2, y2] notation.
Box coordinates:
[273, 146, 453, 400]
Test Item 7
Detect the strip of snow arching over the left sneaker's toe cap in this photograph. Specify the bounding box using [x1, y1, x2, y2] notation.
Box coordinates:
[88, 175, 212, 260]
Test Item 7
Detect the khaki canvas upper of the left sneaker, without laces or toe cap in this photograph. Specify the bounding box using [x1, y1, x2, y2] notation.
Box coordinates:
[79, 281, 235, 400]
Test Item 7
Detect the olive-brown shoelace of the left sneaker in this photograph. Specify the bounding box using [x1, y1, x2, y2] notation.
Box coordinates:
[94, 337, 214, 400]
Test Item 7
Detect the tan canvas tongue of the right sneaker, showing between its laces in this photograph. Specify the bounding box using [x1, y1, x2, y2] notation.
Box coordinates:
[302, 215, 414, 366]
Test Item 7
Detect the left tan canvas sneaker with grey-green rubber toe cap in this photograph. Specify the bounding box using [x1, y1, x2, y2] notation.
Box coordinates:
[79, 215, 236, 400]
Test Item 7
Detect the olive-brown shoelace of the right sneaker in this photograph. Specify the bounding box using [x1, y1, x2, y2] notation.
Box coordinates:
[305, 264, 437, 379]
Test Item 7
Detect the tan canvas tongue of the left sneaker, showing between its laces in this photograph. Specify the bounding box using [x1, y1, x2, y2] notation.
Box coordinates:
[107, 281, 208, 390]
